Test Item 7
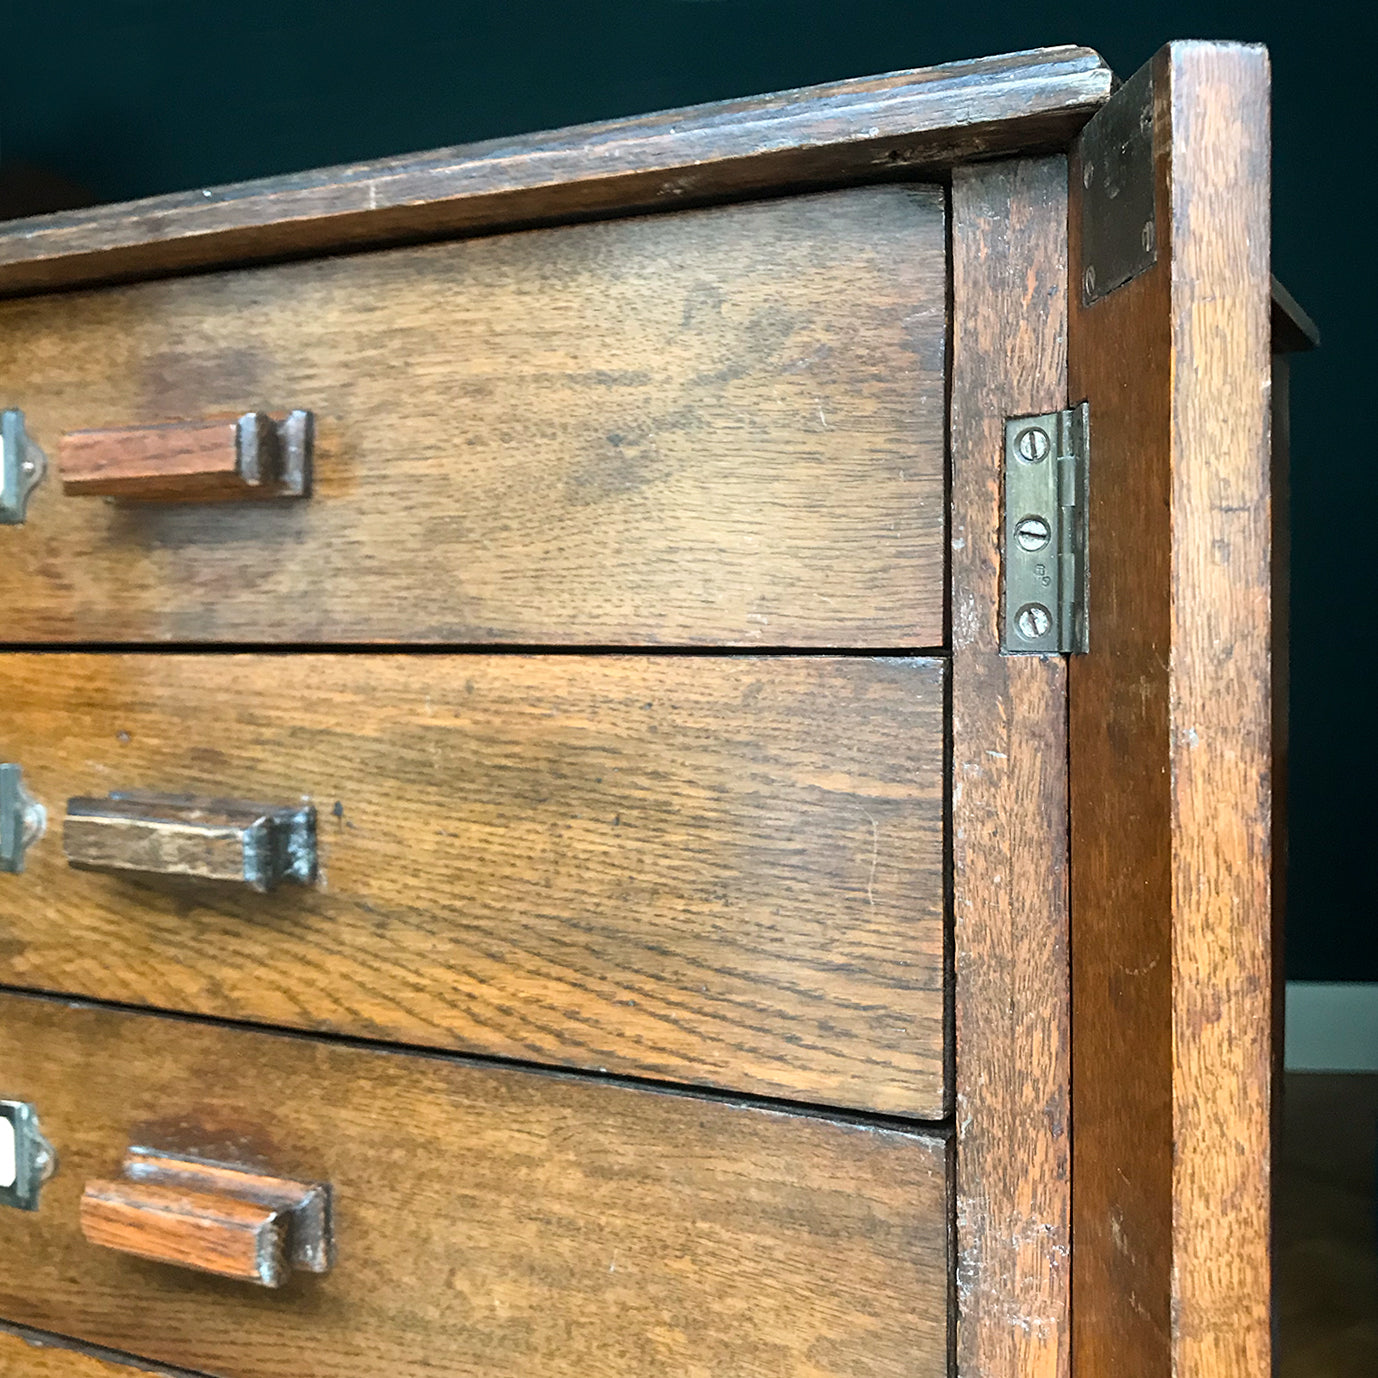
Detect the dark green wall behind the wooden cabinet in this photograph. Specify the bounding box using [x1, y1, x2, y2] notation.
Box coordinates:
[0, 0, 1378, 980]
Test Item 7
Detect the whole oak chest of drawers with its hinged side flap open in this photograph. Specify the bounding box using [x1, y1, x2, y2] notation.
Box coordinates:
[0, 44, 1279, 1378]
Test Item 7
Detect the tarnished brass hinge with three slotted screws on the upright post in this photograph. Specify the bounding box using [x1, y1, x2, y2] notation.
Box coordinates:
[1000, 402, 1091, 656]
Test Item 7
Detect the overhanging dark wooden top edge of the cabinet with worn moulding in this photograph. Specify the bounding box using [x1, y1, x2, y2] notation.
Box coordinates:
[0, 47, 1113, 294]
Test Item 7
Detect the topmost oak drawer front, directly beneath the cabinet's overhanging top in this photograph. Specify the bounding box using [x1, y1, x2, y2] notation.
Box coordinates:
[0, 186, 947, 648]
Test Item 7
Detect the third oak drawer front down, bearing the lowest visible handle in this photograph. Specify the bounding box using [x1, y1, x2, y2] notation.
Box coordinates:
[0, 995, 951, 1378]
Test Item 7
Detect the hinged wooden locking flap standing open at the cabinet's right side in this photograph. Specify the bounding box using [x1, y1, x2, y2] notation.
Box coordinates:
[1069, 43, 1272, 1378]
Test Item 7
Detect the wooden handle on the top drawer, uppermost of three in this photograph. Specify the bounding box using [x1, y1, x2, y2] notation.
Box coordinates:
[58, 412, 314, 503]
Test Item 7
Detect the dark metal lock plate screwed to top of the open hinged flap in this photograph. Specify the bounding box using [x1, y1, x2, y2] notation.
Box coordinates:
[1078, 65, 1158, 306]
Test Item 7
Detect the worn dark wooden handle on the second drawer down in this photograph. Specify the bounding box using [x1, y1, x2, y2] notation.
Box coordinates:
[62, 791, 316, 893]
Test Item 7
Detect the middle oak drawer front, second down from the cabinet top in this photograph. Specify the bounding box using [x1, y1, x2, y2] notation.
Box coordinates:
[0, 653, 947, 1118]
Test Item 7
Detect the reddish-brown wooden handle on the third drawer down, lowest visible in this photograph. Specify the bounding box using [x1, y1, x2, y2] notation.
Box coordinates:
[81, 1148, 333, 1287]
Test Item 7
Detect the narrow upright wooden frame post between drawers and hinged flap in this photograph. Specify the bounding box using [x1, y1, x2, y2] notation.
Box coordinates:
[951, 158, 1071, 1378]
